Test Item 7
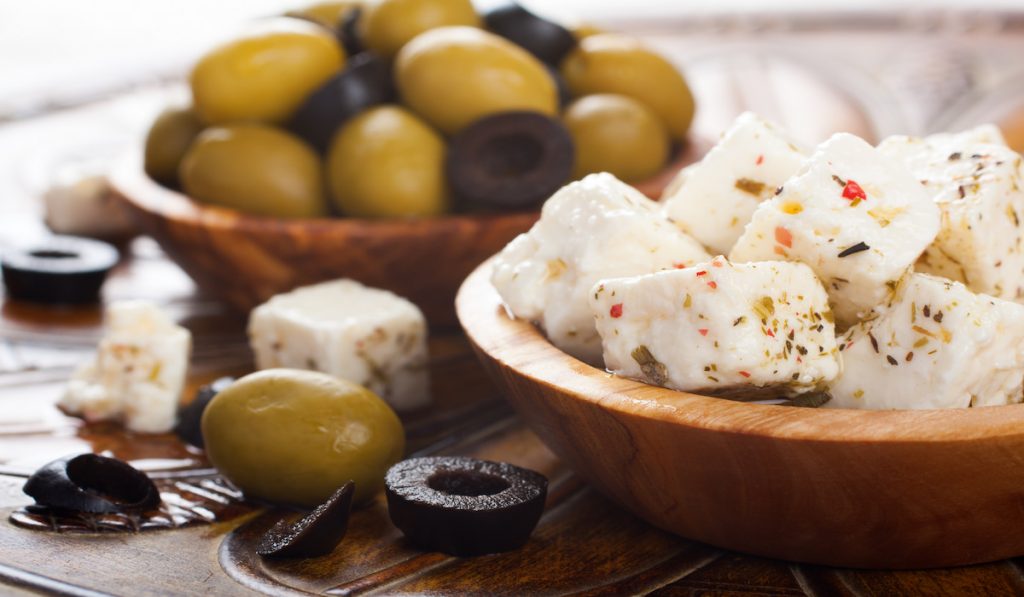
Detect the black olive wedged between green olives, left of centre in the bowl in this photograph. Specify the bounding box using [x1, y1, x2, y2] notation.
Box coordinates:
[288, 52, 394, 154]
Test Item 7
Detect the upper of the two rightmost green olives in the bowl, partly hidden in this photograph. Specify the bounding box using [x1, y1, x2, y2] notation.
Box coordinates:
[561, 34, 693, 140]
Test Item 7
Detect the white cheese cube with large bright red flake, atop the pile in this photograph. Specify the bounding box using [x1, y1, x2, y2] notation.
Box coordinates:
[729, 133, 939, 329]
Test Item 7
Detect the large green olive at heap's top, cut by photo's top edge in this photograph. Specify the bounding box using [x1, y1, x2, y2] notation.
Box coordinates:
[357, 0, 480, 57]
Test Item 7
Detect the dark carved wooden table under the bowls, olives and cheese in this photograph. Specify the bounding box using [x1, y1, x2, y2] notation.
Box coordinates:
[6, 10, 1024, 595]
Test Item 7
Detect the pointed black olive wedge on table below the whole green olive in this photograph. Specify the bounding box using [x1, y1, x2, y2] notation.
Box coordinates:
[256, 481, 355, 558]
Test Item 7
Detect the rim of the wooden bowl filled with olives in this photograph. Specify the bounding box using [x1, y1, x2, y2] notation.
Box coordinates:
[109, 151, 540, 236]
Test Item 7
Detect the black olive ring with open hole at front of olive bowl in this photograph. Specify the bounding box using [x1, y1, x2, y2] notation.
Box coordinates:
[445, 112, 575, 209]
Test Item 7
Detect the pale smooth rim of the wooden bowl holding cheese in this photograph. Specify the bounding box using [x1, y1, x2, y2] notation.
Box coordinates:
[456, 257, 1024, 443]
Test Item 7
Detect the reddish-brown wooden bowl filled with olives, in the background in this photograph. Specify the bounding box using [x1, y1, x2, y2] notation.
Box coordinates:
[111, 149, 710, 327]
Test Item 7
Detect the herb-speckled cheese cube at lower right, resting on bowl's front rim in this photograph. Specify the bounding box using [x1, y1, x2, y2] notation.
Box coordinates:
[826, 273, 1024, 409]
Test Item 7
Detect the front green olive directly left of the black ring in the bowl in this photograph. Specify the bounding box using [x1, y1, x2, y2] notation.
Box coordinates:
[327, 105, 449, 217]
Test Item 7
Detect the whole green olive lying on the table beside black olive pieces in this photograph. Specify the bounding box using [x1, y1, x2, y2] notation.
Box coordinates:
[202, 369, 406, 508]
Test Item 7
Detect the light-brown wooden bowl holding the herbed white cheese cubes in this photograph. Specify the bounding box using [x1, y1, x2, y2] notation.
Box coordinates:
[456, 259, 1024, 568]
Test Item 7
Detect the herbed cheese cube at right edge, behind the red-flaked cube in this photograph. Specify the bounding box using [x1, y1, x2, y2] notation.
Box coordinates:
[879, 126, 1024, 300]
